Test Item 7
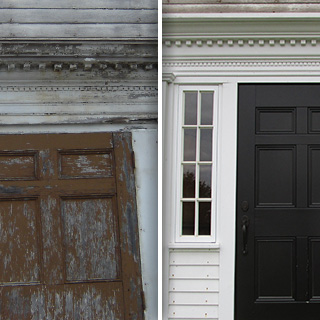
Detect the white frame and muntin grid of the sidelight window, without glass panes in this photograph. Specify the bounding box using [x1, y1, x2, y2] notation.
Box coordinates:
[176, 85, 218, 242]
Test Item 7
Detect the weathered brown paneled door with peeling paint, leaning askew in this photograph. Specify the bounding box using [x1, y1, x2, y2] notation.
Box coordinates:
[0, 133, 143, 320]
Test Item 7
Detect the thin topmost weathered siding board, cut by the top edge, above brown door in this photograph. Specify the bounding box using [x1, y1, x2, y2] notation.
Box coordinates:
[0, 0, 158, 9]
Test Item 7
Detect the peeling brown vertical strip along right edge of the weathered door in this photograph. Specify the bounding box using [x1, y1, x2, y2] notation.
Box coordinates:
[113, 132, 144, 320]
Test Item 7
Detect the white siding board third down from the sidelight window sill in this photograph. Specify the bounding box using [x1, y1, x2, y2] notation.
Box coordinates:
[169, 279, 219, 291]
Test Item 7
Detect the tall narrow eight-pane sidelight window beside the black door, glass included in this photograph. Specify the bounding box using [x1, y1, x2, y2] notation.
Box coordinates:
[178, 89, 217, 242]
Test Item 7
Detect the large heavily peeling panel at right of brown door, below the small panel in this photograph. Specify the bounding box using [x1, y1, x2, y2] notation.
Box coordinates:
[61, 196, 120, 281]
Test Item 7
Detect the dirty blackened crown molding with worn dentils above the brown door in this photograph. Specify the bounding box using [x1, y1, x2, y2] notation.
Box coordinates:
[0, 41, 157, 72]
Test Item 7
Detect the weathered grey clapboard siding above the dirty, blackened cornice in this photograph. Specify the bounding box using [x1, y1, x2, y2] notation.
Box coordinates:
[0, 0, 158, 40]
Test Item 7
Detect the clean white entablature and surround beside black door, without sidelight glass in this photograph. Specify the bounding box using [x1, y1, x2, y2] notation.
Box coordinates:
[162, 13, 320, 320]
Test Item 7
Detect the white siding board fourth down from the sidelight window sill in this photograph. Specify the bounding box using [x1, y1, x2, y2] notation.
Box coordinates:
[169, 291, 219, 305]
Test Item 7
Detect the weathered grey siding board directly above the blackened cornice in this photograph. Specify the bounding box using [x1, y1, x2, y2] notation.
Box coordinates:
[0, 24, 158, 39]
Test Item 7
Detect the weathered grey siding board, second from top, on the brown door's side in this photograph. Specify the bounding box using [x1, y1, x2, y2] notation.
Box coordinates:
[0, 9, 158, 24]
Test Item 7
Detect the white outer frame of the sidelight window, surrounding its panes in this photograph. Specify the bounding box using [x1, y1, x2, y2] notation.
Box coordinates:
[174, 84, 219, 243]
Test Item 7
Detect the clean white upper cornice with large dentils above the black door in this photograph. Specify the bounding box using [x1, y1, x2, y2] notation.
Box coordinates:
[163, 13, 320, 48]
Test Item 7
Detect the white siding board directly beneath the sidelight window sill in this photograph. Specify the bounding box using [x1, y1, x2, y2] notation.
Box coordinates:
[170, 251, 219, 265]
